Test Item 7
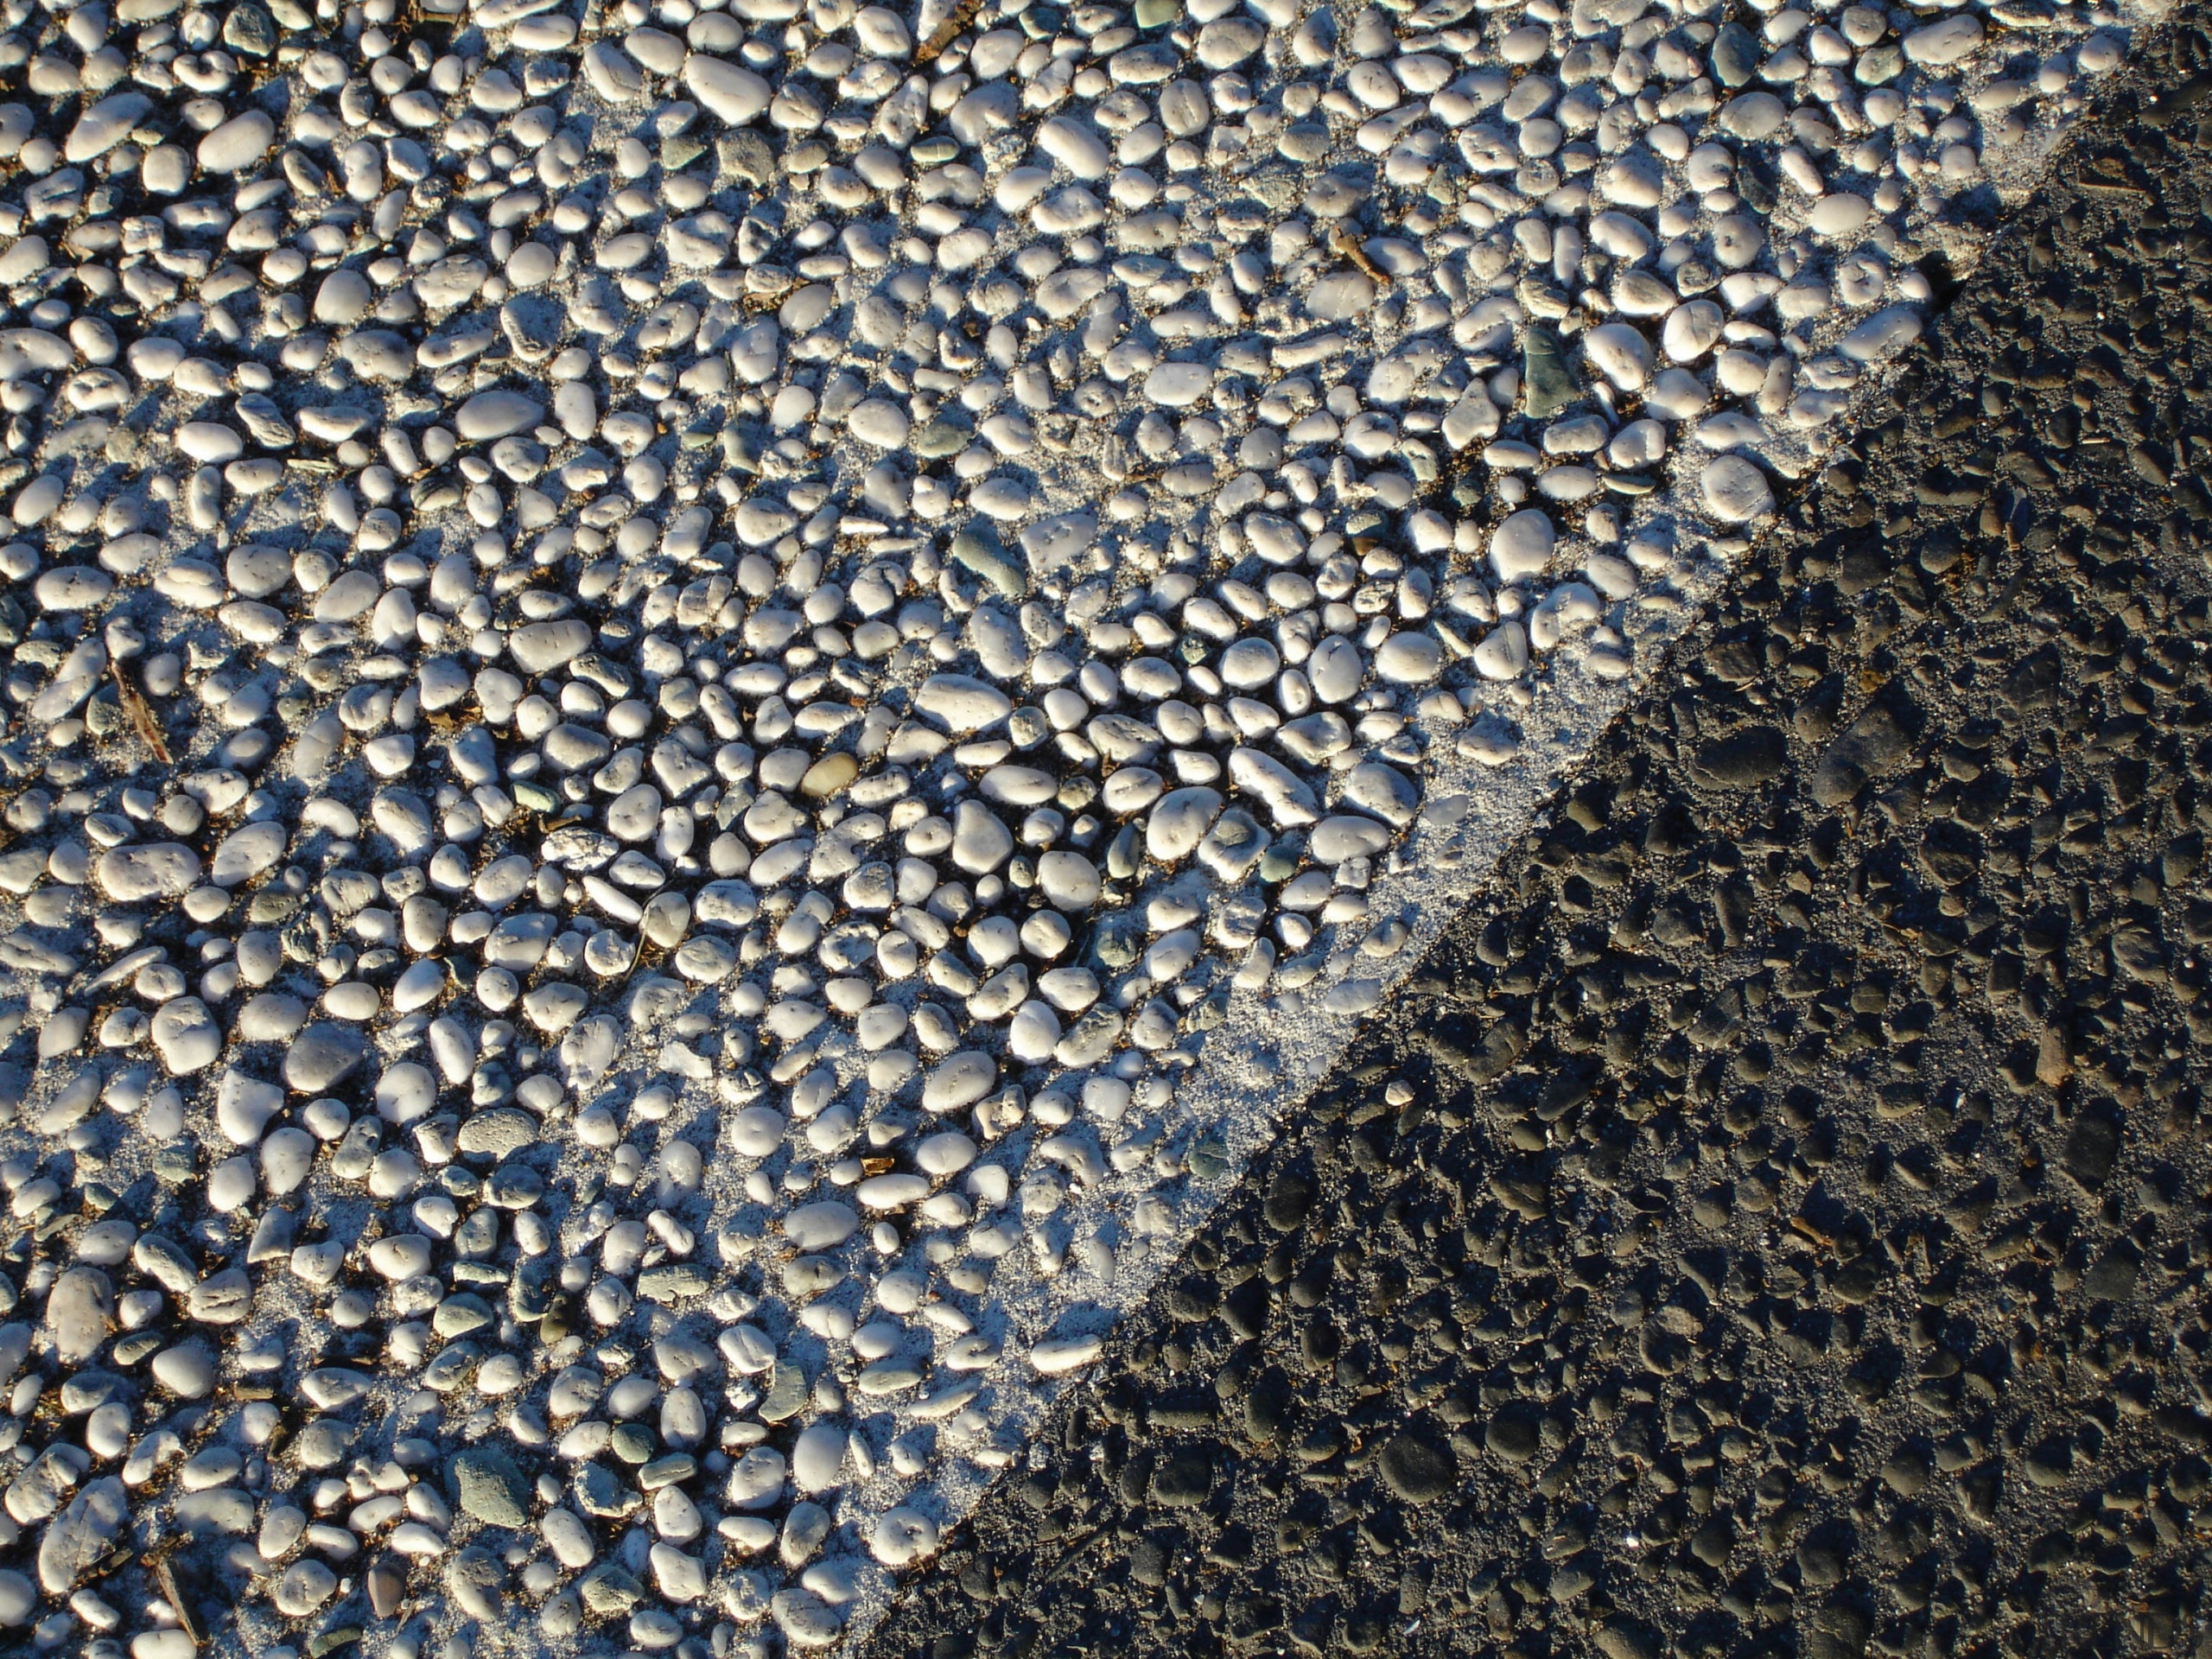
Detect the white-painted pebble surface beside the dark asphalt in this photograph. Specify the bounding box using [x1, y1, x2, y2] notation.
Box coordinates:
[0, 0, 2179, 1659]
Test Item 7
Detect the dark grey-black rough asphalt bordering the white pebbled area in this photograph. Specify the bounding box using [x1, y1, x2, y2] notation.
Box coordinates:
[874, 13, 2212, 1659]
